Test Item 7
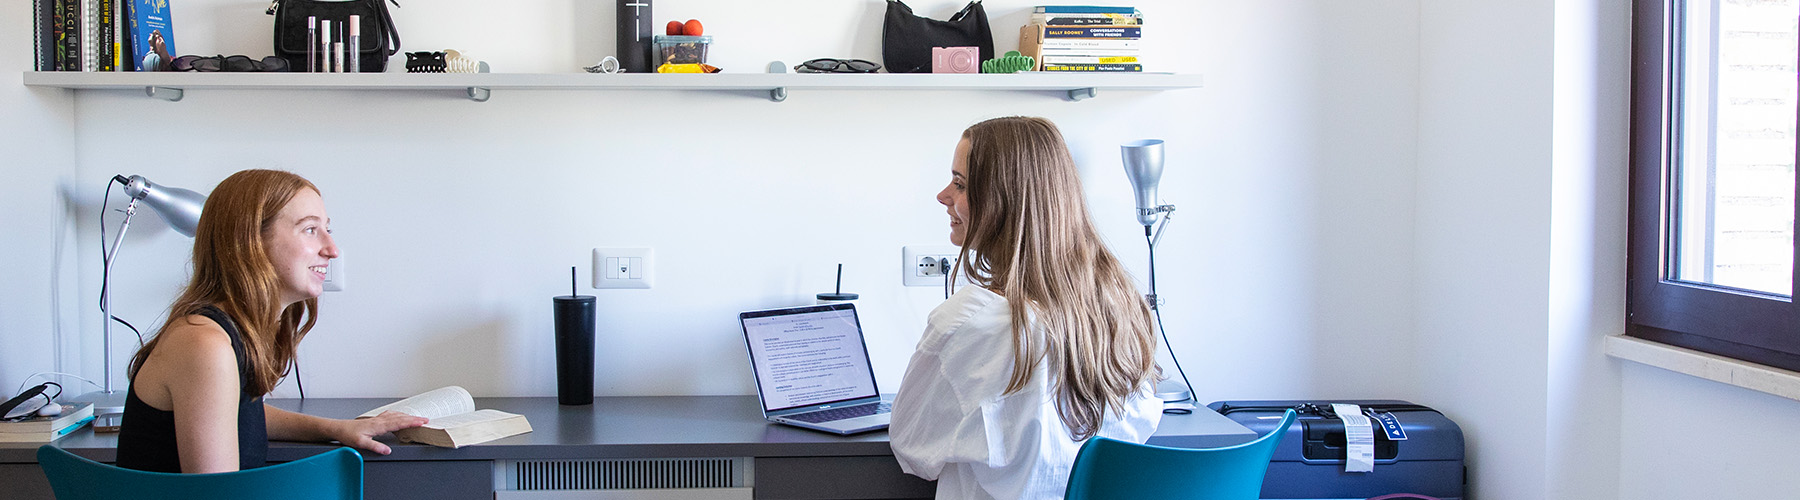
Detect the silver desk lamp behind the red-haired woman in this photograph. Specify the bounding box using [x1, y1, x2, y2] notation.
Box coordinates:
[76, 176, 207, 415]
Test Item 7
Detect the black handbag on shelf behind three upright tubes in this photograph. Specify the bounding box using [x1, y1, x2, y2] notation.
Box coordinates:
[268, 0, 400, 72]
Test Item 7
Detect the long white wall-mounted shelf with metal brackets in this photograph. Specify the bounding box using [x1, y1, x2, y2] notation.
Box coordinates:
[25, 72, 1201, 103]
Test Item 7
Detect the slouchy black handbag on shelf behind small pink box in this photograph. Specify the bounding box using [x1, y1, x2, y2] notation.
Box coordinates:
[882, 0, 994, 74]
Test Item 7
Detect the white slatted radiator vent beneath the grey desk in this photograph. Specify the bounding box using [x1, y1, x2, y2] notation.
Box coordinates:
[502, 459, 751, 491]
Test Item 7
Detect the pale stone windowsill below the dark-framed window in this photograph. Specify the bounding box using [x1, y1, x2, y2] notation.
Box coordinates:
[1606, 335, 1800, 401]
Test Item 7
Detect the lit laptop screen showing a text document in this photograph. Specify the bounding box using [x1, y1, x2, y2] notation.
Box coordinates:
[738, 304, 880, 412]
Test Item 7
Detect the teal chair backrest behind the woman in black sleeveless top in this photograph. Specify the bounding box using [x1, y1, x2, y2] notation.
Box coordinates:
[38, 444, 362, 500]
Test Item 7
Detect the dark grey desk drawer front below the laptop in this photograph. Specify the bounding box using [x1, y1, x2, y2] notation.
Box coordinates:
[756, 455, 938, 500]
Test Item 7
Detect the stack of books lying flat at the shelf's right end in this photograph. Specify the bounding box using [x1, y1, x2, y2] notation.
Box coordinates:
[1019, 5, 1143, 72]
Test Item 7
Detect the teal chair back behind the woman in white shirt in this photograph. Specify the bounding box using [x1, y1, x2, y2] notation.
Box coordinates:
[1064, 410, 1294, 500]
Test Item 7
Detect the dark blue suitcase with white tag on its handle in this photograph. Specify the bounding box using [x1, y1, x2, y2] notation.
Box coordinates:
[1206, 399, 1465, 500]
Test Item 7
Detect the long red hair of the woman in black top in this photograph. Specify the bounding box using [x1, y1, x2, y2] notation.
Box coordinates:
[130, 169, 319, 394]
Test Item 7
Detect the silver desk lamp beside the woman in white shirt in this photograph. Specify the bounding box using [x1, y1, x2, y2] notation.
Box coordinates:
[1120, 138, 1193, 412]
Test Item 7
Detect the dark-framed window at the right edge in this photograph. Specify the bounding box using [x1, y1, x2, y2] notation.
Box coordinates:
[1627, 0, 1800, 371]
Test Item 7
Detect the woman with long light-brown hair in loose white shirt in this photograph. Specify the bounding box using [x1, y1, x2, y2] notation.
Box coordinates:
[889, 117, 1161, 498]
